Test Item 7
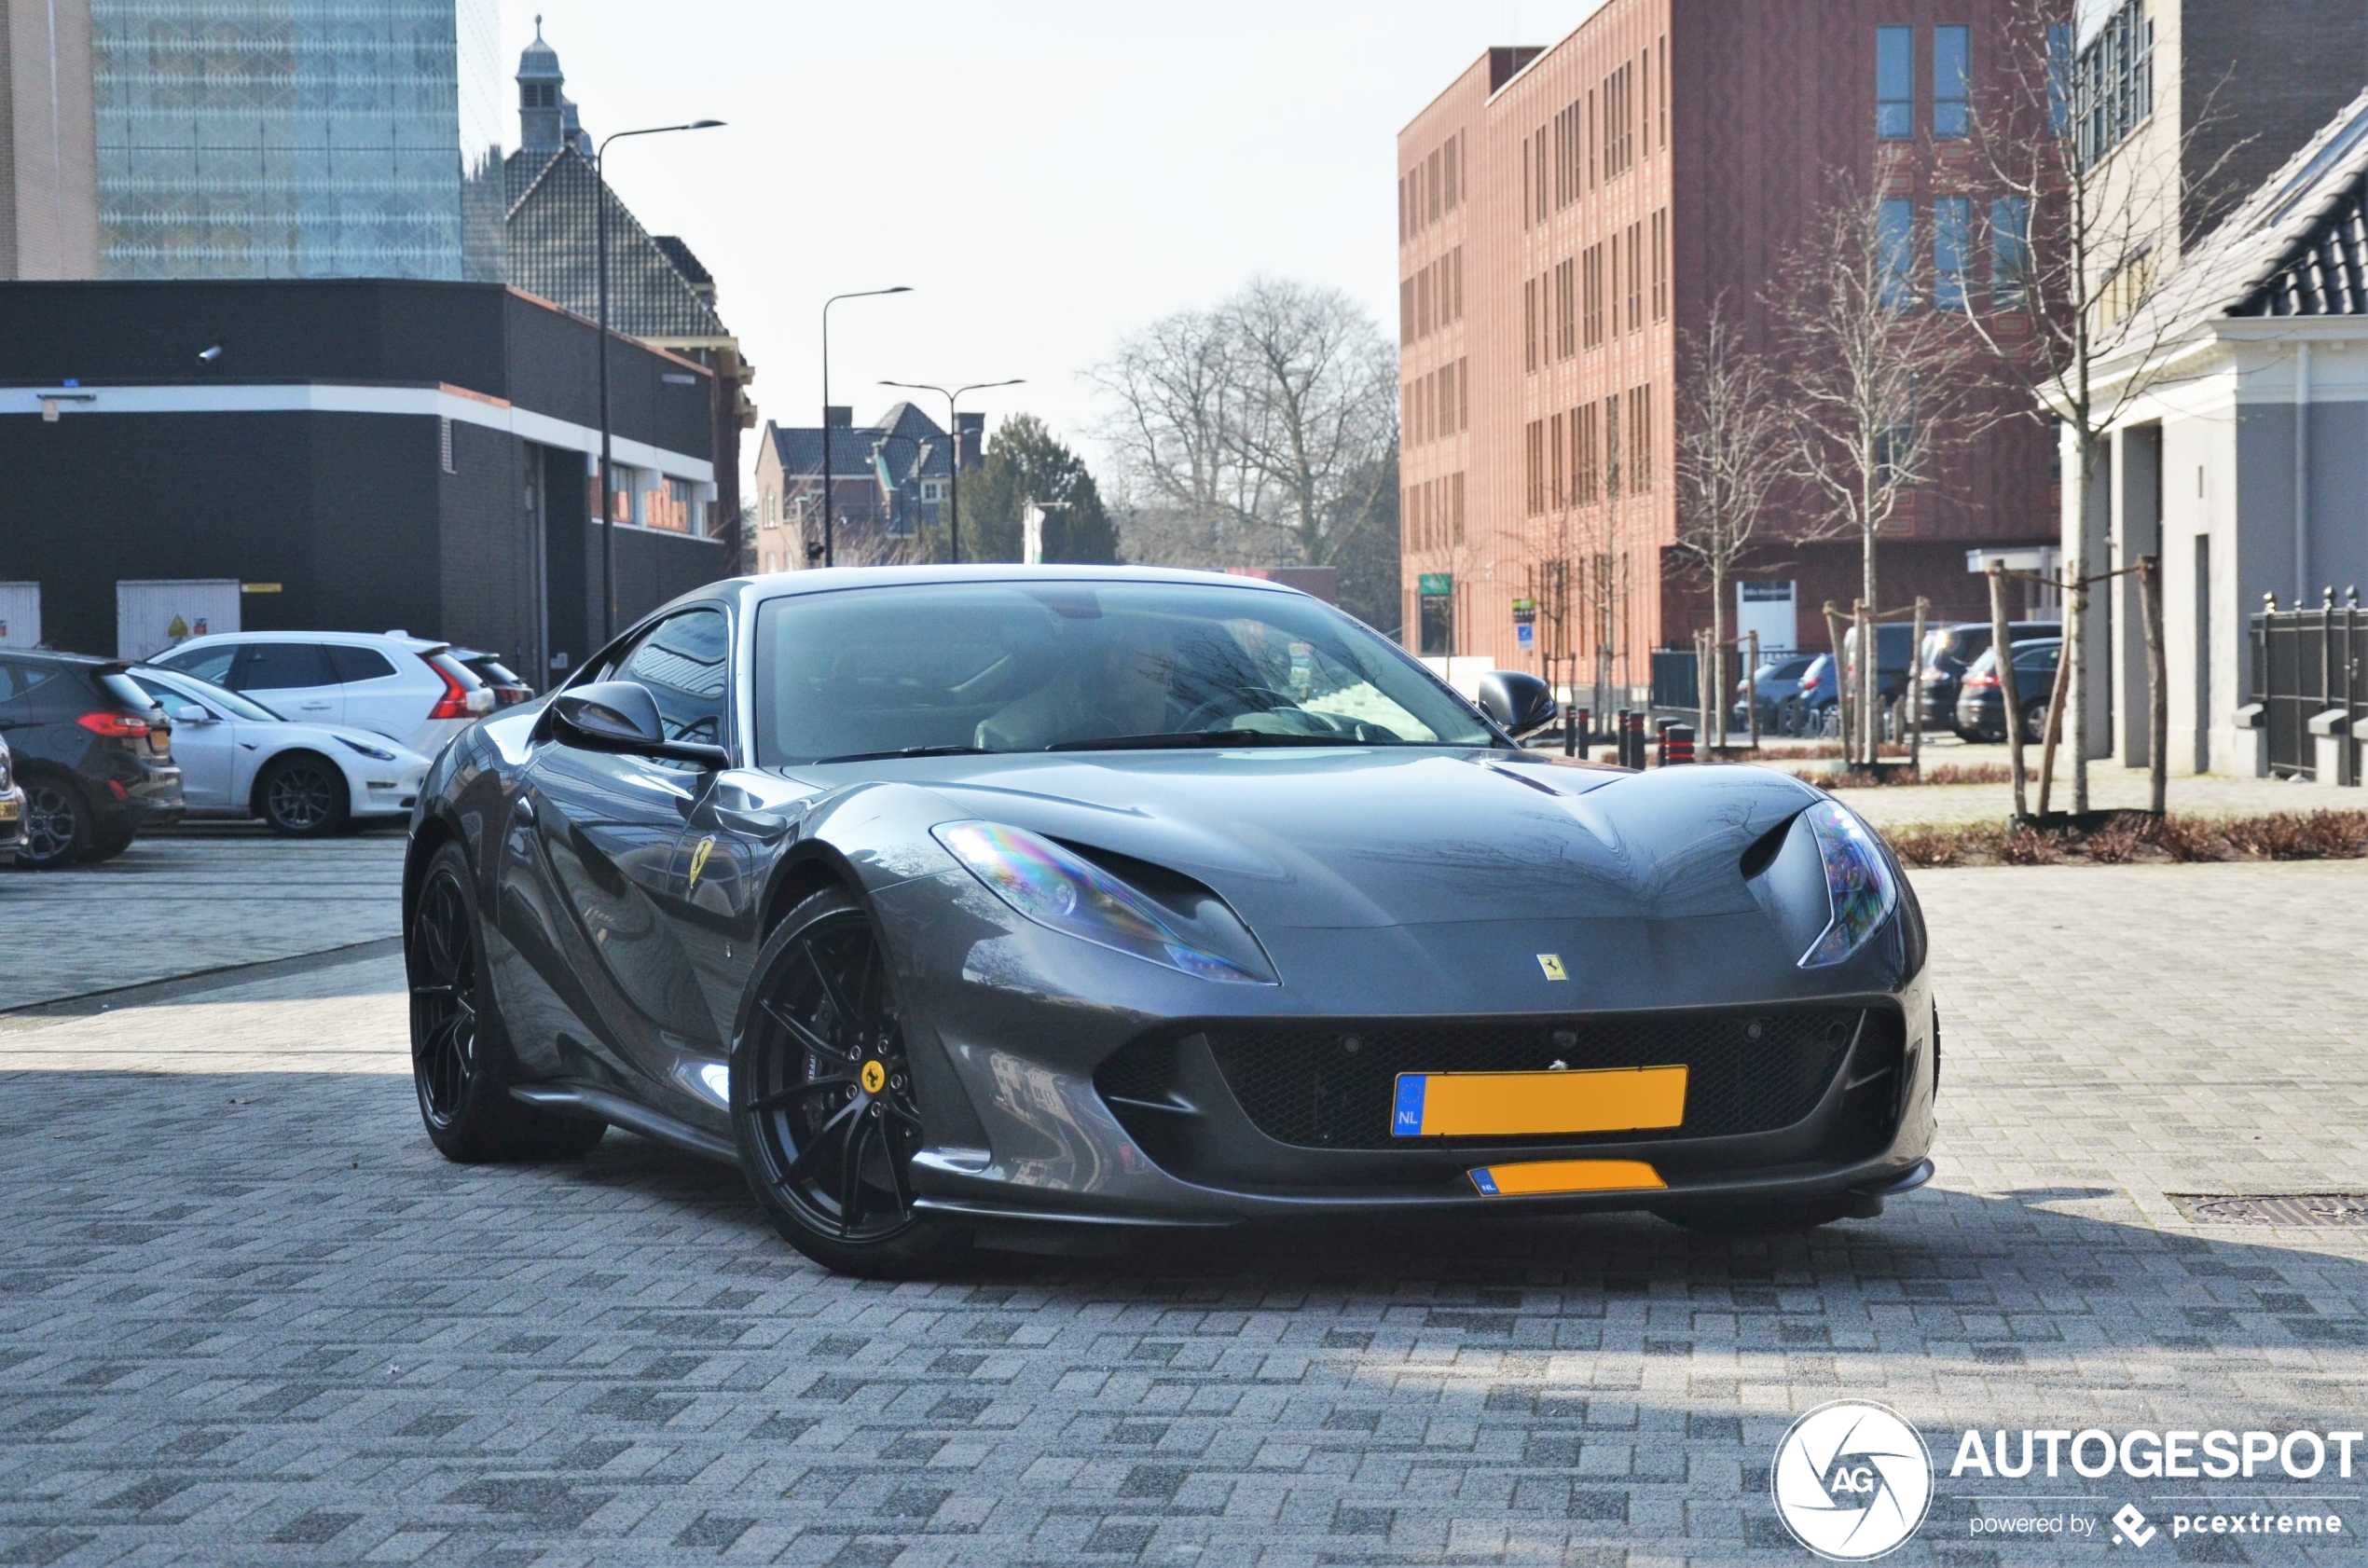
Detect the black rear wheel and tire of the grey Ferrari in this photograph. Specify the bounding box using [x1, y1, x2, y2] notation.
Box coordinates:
[403, 844, 609, 1165]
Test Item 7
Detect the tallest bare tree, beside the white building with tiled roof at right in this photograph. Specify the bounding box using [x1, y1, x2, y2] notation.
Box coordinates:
[1963, 0, 2250, 812]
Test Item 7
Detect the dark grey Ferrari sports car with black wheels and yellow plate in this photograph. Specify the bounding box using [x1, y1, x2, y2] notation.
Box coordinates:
[403, 566, 1939, 1274]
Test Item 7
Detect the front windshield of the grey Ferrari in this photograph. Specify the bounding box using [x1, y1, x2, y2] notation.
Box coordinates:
[755, 578, 1499, 767]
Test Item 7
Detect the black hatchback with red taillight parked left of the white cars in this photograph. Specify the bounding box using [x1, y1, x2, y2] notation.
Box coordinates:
[0, 649, 183, 872]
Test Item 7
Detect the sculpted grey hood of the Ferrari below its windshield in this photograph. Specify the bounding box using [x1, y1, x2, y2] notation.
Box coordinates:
[798, 749, 1819, 931]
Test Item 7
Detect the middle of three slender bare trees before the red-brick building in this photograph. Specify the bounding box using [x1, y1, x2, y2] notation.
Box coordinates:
[1776, 175, 1982, 763]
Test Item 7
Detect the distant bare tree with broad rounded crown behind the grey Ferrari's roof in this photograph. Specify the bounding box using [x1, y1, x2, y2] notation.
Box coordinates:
[1094, 277, 1397, 580]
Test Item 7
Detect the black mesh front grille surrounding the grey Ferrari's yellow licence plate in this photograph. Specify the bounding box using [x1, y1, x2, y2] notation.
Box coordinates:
[1136, 1007, 1866, 1148]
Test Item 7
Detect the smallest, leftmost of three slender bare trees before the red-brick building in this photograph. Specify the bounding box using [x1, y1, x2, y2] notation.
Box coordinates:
[1676, 301, 1790, 746]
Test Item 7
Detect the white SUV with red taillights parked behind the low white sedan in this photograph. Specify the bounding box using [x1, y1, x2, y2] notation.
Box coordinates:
[149, 632, 497, 756]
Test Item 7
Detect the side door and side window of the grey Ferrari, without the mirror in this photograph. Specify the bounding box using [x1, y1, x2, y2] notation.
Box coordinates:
[500, 609, 729, 1099]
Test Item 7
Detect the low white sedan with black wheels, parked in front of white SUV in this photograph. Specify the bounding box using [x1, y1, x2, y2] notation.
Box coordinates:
[131, 666, 429, 838]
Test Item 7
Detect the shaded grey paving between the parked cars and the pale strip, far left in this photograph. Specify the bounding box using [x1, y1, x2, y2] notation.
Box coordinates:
[0, 824, 403, 1011]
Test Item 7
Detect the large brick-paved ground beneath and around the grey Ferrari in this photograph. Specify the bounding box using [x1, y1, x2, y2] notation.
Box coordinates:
[0, 864, 2368, 1568]
